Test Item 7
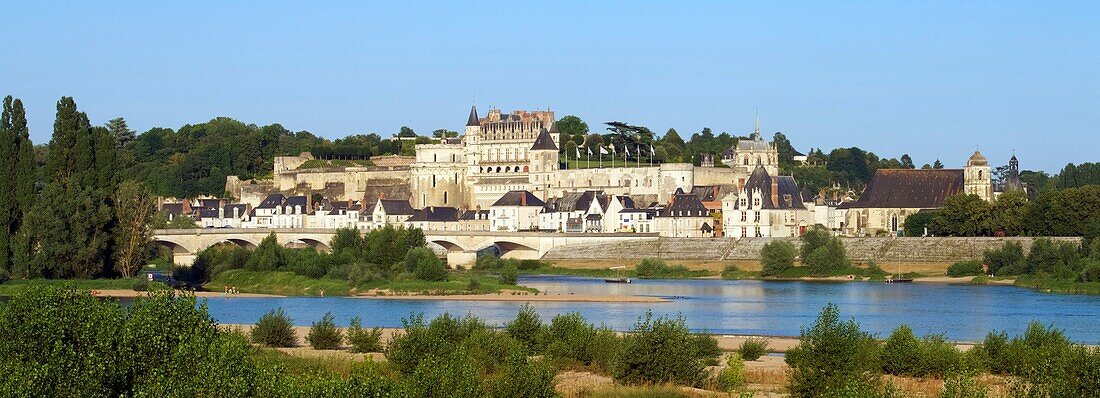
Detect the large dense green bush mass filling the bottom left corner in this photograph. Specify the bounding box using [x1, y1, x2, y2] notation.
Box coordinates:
[0, 286, 260, 397]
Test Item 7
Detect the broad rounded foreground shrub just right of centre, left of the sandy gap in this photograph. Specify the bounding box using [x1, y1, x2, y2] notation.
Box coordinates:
[613, 311, 713, 386]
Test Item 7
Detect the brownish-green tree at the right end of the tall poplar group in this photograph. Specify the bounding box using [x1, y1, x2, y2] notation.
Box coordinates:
[114, 181, 156, 278]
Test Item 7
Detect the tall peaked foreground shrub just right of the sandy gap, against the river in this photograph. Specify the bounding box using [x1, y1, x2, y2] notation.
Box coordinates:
[787, 303, 880, 397]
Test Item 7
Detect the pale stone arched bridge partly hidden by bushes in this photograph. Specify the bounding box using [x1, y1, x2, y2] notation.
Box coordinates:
[153, 229, 658, 266]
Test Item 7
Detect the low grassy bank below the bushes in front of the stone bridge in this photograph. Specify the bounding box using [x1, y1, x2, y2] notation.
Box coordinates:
[206, 269, 538, 296]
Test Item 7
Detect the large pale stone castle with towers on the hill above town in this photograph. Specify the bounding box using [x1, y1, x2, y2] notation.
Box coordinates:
[234, 107, 779, 209]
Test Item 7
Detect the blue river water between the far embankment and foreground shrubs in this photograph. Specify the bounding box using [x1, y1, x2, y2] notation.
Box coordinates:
[207, 276, 1100, 344]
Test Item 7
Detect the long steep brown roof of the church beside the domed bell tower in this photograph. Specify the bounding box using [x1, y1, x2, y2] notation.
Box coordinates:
[839, 168, 964, 209]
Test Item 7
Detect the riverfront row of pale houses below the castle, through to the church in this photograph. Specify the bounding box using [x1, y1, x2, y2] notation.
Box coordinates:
[161, 152, 1012, 237]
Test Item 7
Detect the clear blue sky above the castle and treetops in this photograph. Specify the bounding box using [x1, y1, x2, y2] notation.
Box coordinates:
[0, 1, 1100, 172]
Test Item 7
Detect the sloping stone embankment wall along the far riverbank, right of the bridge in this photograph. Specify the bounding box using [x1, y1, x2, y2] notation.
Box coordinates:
[543, 237, 1080, 264]
